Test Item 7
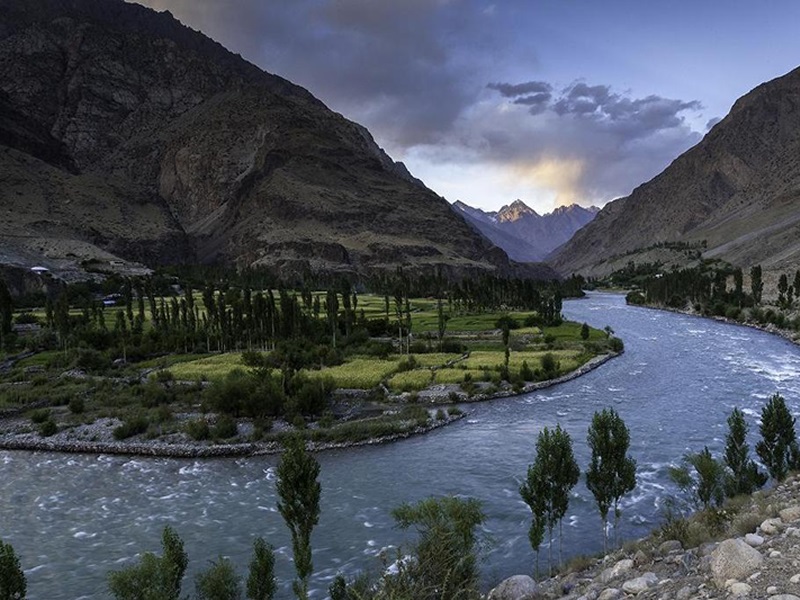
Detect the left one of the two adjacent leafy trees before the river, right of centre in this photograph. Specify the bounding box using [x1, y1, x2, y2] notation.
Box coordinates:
[520, 425, 580, 574]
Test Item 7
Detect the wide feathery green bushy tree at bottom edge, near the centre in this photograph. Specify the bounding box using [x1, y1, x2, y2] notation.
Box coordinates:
[387, 496, 486, 600]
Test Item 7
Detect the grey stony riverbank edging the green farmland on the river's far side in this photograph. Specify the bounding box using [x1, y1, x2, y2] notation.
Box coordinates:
[0, 354, 619, 458]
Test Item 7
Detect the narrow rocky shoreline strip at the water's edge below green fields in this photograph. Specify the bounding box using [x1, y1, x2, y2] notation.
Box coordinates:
[0, 354, 619, 458]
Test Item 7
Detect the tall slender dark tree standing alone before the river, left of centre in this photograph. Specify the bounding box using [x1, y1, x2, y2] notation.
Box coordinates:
[277, 435, 321, 600]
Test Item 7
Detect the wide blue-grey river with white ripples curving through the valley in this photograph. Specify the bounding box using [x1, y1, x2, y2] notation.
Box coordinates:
[0, 294, 800, 600]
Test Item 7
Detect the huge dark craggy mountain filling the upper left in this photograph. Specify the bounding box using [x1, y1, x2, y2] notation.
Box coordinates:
[0, 0, 553, 276]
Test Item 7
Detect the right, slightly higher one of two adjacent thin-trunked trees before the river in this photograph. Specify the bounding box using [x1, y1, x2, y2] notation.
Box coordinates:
[586, 408, 636, 553]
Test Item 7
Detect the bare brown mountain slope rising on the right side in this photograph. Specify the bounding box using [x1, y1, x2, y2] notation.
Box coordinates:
[551, 69, 800, 275]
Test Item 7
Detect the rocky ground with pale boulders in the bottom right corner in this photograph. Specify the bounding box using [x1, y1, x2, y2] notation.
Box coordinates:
[488, 476, 800, 600]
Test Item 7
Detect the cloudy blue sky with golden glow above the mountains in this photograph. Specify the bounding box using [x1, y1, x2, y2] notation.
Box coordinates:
[134, 0, 800, 212]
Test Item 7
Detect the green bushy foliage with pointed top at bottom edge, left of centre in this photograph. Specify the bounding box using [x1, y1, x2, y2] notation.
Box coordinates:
[108, 526, 189, 600]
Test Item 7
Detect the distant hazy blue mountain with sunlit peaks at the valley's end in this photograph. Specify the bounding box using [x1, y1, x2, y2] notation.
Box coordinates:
[453, 200, 600, 262]
